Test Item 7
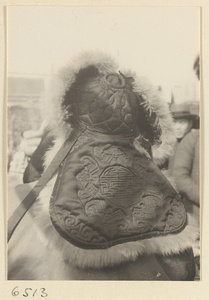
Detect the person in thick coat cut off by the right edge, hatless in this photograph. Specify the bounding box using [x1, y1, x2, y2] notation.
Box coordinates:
[172, 57, 200, 276]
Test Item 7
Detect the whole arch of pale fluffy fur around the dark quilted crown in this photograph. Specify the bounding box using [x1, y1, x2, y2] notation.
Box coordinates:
[46, 52, 175, 165]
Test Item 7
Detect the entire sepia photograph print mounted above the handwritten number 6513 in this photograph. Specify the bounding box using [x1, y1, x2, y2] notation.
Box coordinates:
[6, 6, 201, 281]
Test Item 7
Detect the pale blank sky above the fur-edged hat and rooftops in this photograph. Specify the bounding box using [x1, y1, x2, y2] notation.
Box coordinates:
[7, 6, 200, 102]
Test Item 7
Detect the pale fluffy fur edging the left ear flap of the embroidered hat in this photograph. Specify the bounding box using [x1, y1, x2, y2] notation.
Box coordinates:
[46, 51, 118, 136]
